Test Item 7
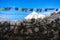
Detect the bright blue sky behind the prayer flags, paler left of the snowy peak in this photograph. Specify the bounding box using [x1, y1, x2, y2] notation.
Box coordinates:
[0, 0, 60, 21]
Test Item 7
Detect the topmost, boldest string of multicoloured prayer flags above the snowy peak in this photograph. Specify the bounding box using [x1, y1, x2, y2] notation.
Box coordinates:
[0, 7, 59, 12]
